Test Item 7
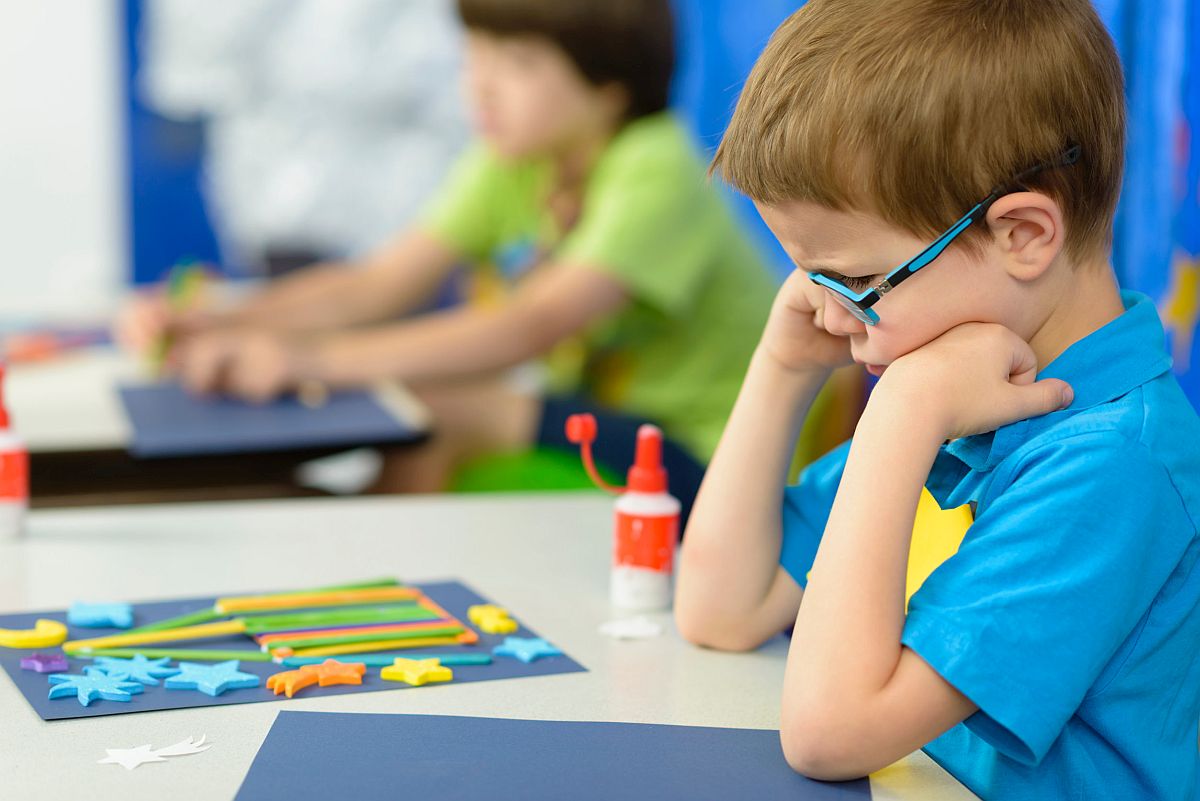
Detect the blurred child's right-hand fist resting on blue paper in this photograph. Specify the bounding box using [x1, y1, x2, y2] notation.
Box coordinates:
[178, 329, 304, 403]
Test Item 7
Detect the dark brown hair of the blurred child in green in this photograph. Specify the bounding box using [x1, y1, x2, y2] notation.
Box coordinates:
[458, 0, 674, 120]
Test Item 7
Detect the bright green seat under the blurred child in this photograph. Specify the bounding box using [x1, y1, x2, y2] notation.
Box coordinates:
[450, 447, 624, 493]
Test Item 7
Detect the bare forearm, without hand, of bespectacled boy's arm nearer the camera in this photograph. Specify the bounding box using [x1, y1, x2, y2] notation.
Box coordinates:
[784, 390, 943, 716]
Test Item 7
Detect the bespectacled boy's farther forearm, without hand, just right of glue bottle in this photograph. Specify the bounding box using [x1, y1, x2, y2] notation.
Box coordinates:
[676, 348, 829, 645]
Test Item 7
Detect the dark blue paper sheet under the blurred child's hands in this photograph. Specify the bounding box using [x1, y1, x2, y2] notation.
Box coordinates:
[120, 383, 424, 458]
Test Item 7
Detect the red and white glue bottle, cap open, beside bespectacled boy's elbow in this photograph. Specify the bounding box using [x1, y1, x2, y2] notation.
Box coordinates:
[566, 415, 680, 612]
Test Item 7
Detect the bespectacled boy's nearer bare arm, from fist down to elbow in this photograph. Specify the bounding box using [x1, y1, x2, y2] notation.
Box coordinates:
[781, 324, 1063, 779]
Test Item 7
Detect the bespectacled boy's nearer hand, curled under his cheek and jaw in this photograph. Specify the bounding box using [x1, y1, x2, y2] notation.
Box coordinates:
[875, 323, 1074, 439]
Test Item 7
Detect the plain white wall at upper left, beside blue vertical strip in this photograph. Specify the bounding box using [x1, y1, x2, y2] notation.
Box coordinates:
[0, 0, 127, 320]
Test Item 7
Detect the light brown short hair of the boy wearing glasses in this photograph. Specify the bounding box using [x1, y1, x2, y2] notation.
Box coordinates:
[712, 0, 1124, 259]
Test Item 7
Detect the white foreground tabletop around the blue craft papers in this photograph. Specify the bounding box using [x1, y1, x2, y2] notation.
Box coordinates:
[0, 493, 974, 801]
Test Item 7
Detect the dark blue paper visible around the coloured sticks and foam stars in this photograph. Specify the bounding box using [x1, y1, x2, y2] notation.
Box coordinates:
[0, 582, 584, 721]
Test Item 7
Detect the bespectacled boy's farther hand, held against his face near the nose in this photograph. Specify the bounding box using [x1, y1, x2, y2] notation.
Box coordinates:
[762, 270, 853, 372]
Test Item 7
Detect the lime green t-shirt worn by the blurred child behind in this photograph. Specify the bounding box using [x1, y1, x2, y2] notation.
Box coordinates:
[424, 113, 775, 462]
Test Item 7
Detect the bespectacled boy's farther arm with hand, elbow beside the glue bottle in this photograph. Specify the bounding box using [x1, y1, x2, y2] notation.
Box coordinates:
[676, 271, 848, 650]
